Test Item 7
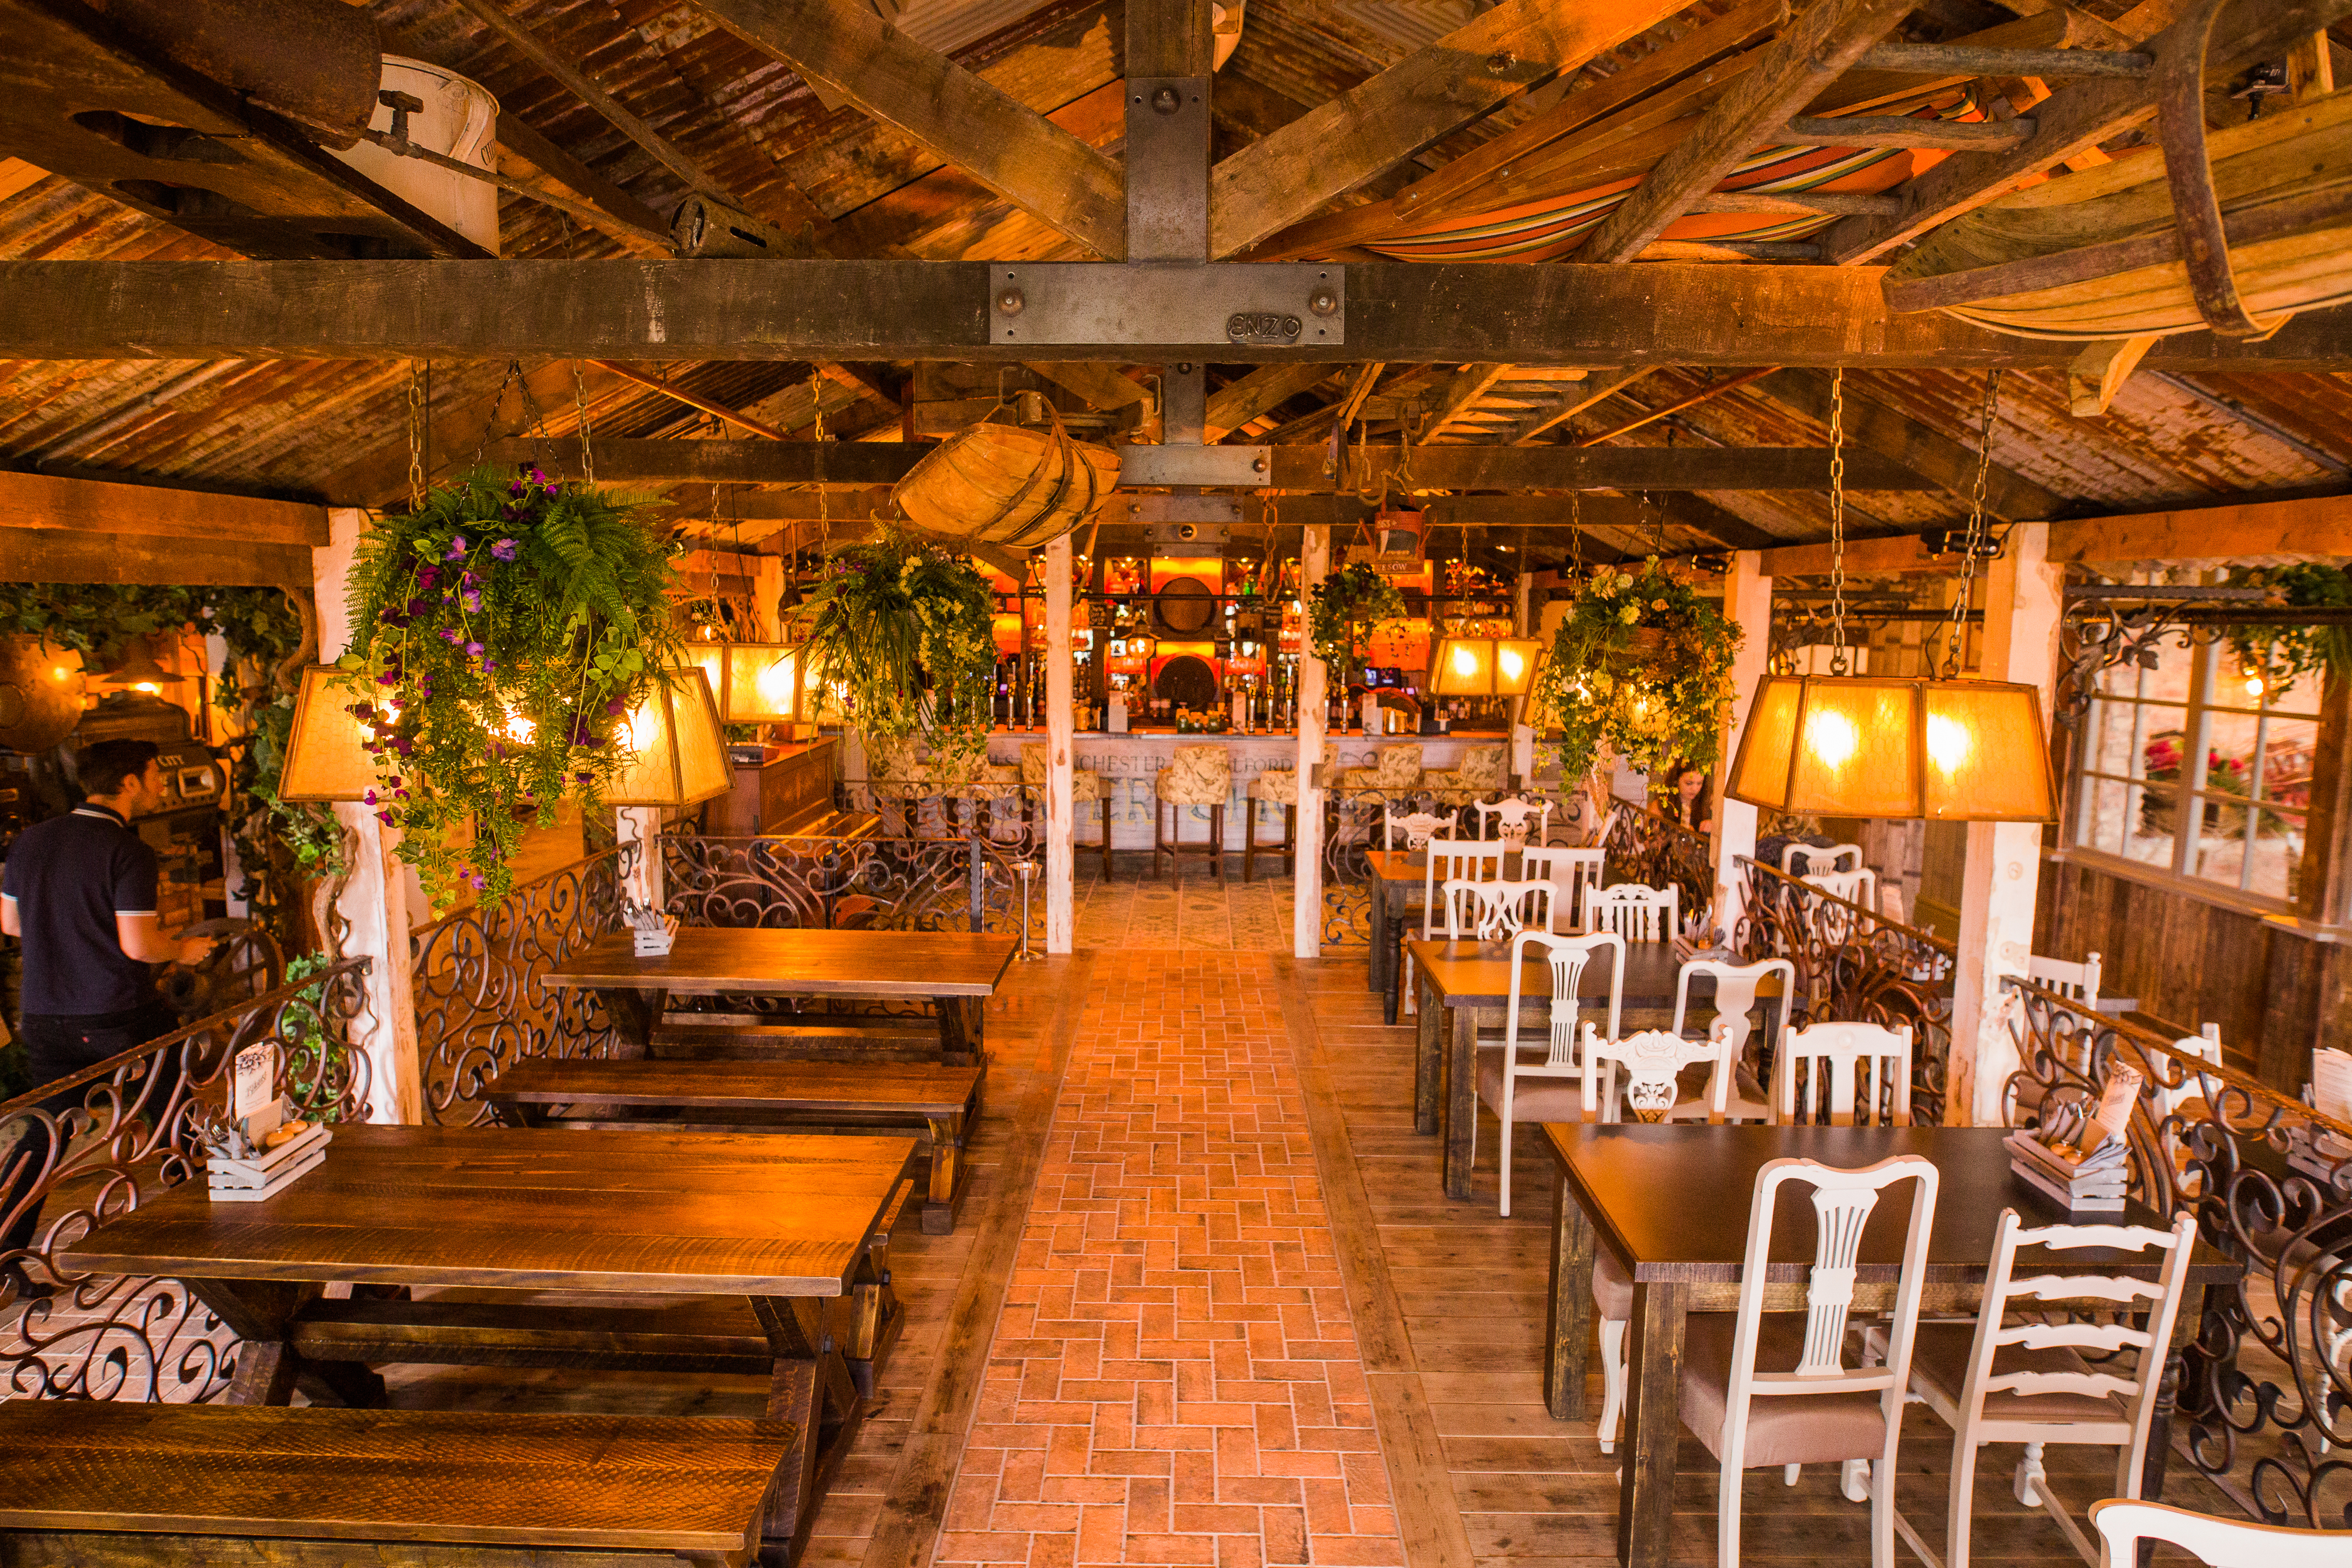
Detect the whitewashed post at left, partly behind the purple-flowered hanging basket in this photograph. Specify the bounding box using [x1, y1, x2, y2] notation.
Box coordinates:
[310, 508, 430, 1121]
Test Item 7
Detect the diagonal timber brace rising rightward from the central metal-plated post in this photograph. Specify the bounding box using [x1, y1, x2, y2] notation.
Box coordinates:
[1209, 0, 1693, 256]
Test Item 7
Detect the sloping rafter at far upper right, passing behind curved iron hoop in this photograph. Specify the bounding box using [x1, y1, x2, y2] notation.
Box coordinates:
[1818, 0, 2352, 266]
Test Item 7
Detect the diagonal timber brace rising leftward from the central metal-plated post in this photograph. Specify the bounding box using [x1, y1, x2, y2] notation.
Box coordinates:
[691, 0, 1127, 261]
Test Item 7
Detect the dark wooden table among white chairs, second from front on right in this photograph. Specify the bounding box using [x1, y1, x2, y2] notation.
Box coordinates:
[1404, 938, 1722, 1199]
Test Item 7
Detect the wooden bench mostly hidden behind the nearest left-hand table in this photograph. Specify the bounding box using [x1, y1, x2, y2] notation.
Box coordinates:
[287, 1182, 915, 1399]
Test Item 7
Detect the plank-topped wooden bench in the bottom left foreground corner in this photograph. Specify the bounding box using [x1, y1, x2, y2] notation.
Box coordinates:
[0, 1399, 814, 1568]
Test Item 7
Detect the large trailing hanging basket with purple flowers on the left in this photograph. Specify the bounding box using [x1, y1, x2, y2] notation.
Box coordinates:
[343, 468, 682, 902]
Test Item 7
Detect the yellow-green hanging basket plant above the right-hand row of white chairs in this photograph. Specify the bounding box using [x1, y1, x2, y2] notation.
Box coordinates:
[1536, 557, 1740, 781]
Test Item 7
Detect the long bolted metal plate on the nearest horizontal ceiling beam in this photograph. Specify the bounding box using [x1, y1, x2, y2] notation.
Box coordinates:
[988, 261, 1348, 357]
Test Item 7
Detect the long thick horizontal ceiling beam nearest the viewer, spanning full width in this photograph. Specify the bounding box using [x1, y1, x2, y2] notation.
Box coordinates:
[0, 261, 2352, 374]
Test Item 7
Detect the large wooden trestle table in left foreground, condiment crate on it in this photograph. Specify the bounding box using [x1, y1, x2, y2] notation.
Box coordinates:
[59, 1126, 915, 1542]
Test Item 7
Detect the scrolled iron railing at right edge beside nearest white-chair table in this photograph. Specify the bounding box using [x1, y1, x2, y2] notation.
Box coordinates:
[1980, 978, 2352, 1530]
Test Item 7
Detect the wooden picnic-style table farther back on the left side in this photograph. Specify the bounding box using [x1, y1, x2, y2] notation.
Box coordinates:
[548, 926, 1018, 1062]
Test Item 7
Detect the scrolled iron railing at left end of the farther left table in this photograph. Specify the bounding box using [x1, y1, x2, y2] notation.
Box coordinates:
[409, 846, 635, 1124]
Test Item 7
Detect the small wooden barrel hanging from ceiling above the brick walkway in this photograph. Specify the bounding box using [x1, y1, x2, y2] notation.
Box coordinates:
[891, 414, 1120, 550]
